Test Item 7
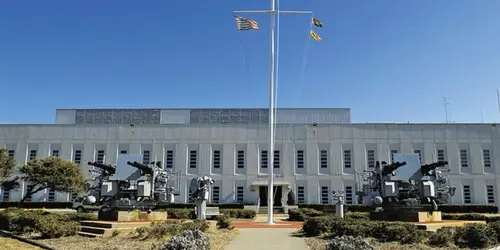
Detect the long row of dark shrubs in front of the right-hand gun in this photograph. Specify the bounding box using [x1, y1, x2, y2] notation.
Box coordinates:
[302, 216, 500, 249]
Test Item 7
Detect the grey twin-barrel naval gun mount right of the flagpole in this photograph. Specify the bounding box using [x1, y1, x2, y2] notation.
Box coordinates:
[357, 154, 455, 212]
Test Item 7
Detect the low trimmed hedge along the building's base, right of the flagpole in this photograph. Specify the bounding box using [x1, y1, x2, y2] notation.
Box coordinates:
[298, 204, 498, 214]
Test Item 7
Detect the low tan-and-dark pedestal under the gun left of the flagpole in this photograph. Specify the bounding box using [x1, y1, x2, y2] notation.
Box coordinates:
[98, 210, 167, 221]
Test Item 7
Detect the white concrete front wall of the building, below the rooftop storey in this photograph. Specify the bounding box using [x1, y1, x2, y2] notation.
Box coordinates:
[0, 124, 500, 205]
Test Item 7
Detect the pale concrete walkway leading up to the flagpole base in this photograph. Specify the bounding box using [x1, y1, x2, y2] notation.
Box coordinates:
[224, 228, 309, 250]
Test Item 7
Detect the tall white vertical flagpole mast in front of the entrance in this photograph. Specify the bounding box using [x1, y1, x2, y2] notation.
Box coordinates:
[267, 0, 276, 224]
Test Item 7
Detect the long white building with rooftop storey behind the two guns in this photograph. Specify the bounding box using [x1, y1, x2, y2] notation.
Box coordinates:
[0, 109, 500, 206]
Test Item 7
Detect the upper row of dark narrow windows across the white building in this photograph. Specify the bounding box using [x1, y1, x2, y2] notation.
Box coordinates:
[8, 149, 492, 169]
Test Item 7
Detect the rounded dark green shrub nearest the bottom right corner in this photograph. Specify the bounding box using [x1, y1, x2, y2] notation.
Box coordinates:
[455, 223, 497, 248]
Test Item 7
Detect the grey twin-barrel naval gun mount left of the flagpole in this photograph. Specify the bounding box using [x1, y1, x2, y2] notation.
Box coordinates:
[80, 154, 180, 213]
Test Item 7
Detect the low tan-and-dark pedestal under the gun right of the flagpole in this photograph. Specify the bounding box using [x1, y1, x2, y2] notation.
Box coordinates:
[370, 211, 442, 222]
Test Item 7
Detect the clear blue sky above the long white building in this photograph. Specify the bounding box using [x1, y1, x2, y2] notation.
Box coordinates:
[0, 0, 500, 123]
